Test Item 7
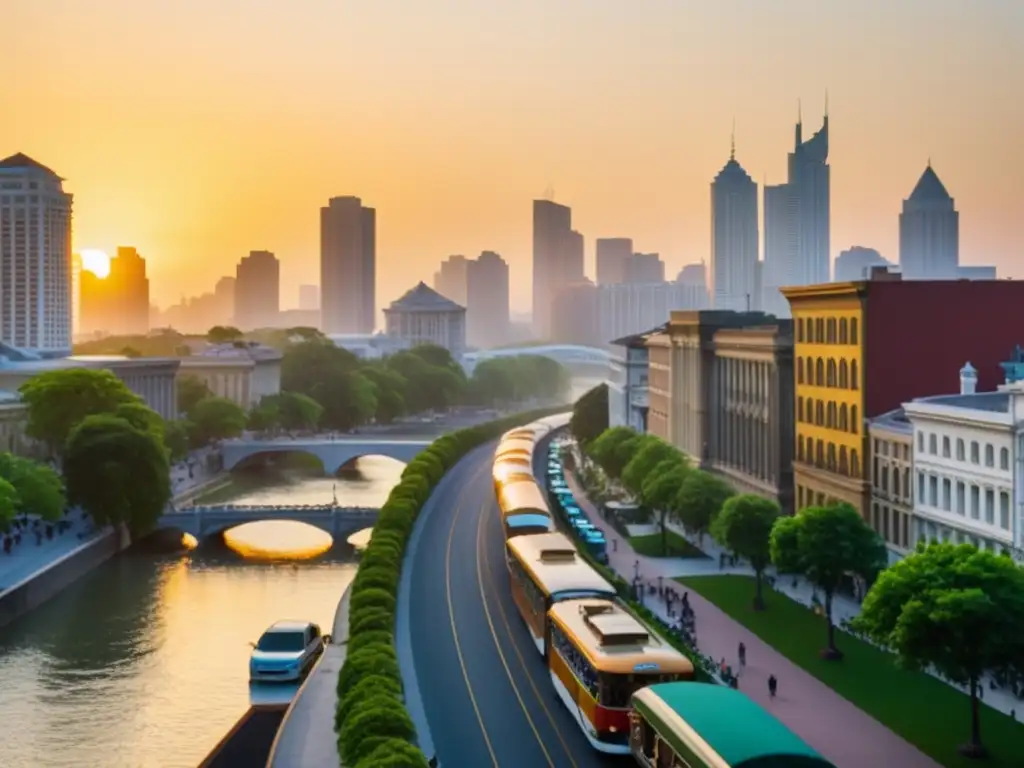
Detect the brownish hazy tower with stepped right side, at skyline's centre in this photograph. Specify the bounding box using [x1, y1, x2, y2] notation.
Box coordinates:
[534, 200, 584, 339]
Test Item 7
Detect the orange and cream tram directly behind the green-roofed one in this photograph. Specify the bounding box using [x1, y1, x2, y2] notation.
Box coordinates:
[548, 599, 693, 755]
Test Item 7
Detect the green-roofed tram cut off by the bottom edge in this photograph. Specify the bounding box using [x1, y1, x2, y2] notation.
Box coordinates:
[630, 683, 835, 768]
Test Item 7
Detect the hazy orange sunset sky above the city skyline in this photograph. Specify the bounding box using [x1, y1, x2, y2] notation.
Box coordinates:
[0, 0, 1024, 309]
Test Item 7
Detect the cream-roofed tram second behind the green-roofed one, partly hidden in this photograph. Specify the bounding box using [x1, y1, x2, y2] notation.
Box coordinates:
[505, 532, 615, 656]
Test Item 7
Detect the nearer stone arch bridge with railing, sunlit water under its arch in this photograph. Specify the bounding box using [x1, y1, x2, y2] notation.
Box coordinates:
[157, 504, 380, 540]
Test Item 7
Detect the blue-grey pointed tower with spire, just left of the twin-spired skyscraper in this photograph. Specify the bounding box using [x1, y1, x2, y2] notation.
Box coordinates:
[711, 141, 761, 312]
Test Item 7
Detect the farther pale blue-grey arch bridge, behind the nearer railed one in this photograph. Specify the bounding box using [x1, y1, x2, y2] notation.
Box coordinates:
[220, 437, 431, 475]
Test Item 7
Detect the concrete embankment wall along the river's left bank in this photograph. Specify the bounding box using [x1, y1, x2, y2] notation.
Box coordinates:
[0, 528, 131, 627]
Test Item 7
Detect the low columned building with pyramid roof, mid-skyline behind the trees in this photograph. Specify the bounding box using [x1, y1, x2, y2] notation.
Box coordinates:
[384, 283, 466, 356]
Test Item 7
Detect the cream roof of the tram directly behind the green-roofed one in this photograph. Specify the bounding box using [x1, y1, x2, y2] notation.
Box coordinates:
[550, 598, 693, 675]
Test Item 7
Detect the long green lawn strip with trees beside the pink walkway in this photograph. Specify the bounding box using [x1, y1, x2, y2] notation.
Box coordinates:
[678, 575, 1024, 768]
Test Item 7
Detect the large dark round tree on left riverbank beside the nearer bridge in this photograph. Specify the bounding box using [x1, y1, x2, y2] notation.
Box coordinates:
[63, 414, 171, 536]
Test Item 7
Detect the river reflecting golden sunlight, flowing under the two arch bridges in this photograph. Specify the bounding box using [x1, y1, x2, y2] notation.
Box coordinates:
[0, 457, 402, 768]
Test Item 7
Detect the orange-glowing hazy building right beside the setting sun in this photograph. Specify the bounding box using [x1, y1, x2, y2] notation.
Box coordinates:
[79, 247, 150, 336]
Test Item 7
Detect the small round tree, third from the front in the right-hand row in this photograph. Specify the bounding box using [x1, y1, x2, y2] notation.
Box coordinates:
[711, 494, 782, 610]
